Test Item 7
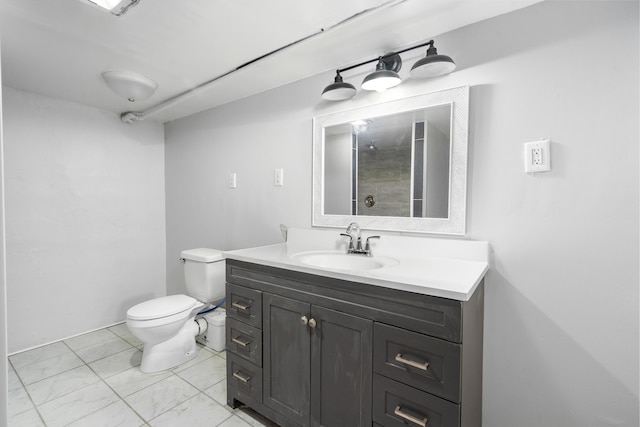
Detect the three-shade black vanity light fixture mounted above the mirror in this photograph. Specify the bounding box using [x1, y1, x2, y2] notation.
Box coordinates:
[321, 40, 456, 101]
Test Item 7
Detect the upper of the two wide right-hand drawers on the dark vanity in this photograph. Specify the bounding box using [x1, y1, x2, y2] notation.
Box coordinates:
[373, 323, 460, 403]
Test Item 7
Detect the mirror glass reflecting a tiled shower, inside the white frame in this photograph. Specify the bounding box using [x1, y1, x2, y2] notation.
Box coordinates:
[324, 104, 452, 218]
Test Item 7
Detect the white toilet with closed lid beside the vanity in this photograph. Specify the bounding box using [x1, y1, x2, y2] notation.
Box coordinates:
[127, 248, 225, 373]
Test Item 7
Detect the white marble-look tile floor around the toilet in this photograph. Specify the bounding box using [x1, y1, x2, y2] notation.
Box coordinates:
[7, 323, 274, 427]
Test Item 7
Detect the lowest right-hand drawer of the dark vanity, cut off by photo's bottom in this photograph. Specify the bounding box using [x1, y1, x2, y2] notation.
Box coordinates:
[373, 374, 460, 427]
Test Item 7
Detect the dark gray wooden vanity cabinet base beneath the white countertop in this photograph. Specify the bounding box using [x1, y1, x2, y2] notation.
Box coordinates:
[226, 259, 484, 427]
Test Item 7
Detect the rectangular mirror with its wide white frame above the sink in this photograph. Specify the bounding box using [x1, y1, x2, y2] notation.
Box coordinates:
[313, 86, 469, 235]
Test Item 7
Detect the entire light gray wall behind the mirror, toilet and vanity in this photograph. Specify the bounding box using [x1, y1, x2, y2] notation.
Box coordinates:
[166, 2, 640, 427]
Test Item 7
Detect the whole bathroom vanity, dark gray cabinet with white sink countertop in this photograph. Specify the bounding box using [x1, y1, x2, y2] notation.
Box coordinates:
[225, 230, 488, 427]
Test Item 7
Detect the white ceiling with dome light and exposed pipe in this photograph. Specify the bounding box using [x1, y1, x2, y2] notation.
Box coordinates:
[0, 0, 540, 122]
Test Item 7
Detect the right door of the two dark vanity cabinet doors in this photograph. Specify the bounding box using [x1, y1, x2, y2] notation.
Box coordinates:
[310, 306, 373, 427]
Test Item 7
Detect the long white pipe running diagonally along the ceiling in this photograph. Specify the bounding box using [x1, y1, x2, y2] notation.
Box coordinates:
[120, 0, 407, 124]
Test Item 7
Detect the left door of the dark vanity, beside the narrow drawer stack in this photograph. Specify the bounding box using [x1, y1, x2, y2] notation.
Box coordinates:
[262, 293, 311, 426]
